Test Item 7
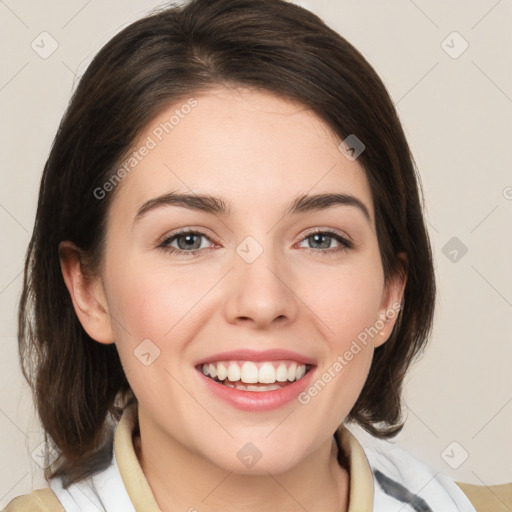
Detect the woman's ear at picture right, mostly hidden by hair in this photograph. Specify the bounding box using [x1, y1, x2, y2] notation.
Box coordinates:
[374, 252, 407, 348]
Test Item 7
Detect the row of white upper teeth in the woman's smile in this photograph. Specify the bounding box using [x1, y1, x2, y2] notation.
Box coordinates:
[201, 361, 307, 384]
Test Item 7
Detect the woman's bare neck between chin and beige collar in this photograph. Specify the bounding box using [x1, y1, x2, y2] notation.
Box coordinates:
[134, 412, 350, 512]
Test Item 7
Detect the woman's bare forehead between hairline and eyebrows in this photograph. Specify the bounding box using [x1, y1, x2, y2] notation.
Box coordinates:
[112, 87, 373, 224]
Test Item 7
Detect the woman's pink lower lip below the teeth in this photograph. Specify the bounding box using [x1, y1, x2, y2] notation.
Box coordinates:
[197, 368, 314, 412]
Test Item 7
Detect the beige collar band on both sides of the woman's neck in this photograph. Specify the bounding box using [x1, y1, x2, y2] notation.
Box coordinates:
[114, 405, 374, 512]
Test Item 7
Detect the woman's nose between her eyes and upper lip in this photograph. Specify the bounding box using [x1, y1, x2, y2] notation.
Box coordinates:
[224, 242, 299, 329]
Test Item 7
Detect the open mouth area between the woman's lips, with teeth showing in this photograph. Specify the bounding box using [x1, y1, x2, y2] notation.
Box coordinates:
[197, 360, 311, 392]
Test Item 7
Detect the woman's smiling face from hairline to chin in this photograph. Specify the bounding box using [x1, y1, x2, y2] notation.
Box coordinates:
[85, 88, 400, 472]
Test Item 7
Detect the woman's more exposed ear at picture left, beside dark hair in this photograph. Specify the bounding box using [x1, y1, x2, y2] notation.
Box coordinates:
[59, 241, 115, 344]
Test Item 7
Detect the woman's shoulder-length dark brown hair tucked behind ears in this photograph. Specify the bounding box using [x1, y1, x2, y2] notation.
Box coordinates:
[19, 0, 435, 487]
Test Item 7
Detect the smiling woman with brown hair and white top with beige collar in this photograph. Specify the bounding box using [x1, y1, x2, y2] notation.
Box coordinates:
[7, 0, 480, 512]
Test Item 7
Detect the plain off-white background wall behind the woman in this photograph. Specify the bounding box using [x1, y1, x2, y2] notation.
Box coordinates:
[0, 0, 512, 507]
